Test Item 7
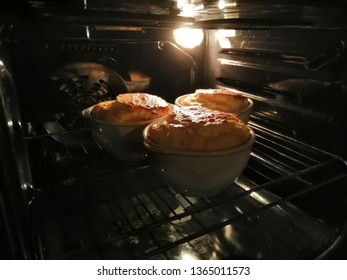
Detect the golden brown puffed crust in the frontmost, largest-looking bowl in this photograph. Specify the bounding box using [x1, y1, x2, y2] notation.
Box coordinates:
[147, 106, 251, 151]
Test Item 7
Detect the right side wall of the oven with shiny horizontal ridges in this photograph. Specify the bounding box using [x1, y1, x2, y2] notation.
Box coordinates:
[205, 28, 347, 158]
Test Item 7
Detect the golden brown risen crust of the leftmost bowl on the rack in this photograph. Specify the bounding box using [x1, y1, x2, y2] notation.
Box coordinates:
[90, 93, 170, 123]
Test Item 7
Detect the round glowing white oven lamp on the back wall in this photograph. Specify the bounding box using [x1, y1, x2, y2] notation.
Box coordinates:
[173, 28, 204, 49]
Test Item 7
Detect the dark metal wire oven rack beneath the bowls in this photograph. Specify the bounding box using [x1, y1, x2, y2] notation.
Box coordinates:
[28, 122, 347, 259]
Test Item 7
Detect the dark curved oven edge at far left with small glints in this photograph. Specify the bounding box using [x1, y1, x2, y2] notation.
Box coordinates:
[0, 55, 34, 259]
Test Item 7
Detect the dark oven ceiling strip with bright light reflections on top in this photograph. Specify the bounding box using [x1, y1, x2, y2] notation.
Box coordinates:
[23, 0, 347, 29]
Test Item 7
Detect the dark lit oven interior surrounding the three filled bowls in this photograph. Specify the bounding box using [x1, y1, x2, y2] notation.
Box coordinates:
[0, 1, 347, 259]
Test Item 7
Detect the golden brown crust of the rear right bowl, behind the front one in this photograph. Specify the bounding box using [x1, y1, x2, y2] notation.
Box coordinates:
[181, 89, 249, 113]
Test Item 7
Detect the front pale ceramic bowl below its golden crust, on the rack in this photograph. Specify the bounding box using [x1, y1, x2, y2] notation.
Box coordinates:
[143, 122, 255, 197]
